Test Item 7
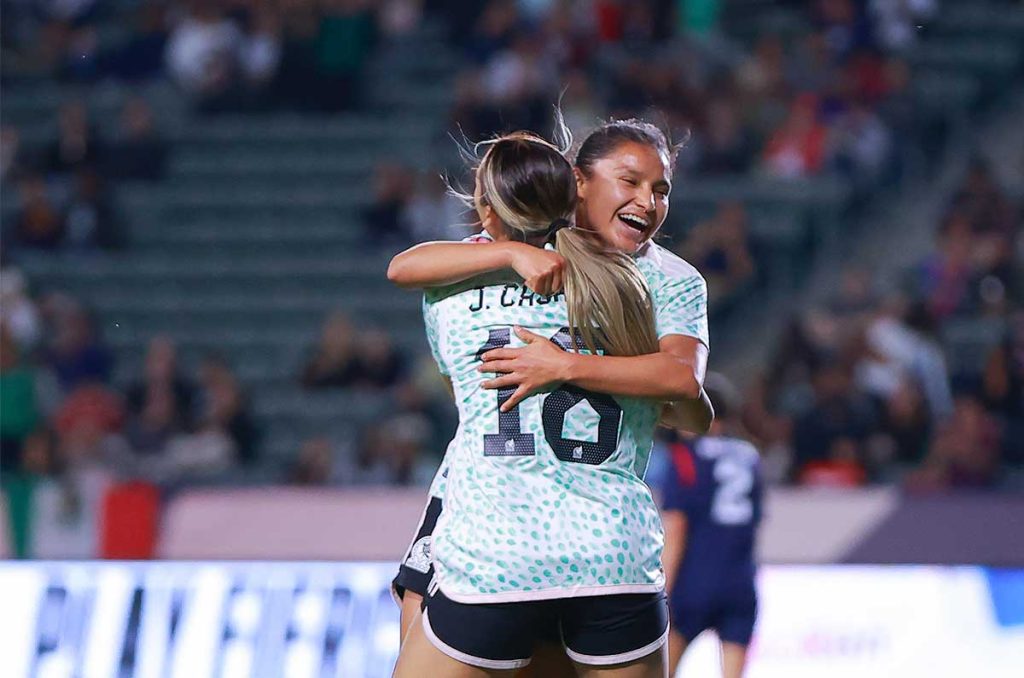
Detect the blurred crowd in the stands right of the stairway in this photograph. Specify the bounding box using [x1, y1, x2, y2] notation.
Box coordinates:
[743, 162, 1024, 490]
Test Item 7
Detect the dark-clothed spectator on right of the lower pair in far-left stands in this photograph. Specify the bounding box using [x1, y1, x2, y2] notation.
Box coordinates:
[63, 168, 123, 250]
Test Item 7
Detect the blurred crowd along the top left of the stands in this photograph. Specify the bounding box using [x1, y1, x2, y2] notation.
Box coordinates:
[3, 0, 422, 113]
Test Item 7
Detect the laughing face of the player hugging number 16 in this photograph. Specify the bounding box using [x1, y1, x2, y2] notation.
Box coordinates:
[577, 141, 672, 254]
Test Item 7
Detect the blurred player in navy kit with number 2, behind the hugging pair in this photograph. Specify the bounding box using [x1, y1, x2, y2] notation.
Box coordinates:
[662, 374, 763, 678]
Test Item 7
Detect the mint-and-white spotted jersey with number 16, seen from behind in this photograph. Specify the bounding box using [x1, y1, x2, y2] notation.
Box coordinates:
[424, 281, 664, 602]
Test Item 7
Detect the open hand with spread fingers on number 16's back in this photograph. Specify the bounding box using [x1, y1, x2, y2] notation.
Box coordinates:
[477, 327, 572, 412]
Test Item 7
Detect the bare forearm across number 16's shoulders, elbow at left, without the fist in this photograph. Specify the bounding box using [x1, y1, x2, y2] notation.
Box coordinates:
[387, 242, 510, 288]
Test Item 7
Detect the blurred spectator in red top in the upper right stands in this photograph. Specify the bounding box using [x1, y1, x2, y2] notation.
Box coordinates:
[762, 94, 827, 178]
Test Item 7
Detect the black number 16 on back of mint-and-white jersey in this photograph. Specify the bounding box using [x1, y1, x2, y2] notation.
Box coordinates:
[476, 328, 623, 465]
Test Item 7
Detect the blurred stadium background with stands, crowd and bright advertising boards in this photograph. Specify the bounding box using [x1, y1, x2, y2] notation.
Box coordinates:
[0, 0, 1024, 678]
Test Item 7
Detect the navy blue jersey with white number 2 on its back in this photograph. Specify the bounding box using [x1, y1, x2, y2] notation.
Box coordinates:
[664, 436, 763, 603]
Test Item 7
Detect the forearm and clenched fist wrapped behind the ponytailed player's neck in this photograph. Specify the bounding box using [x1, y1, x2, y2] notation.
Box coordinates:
[387, 241, 565, 296]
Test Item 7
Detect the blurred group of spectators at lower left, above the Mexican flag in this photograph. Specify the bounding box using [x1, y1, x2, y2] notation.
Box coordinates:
[0, 280, 259, 486]
